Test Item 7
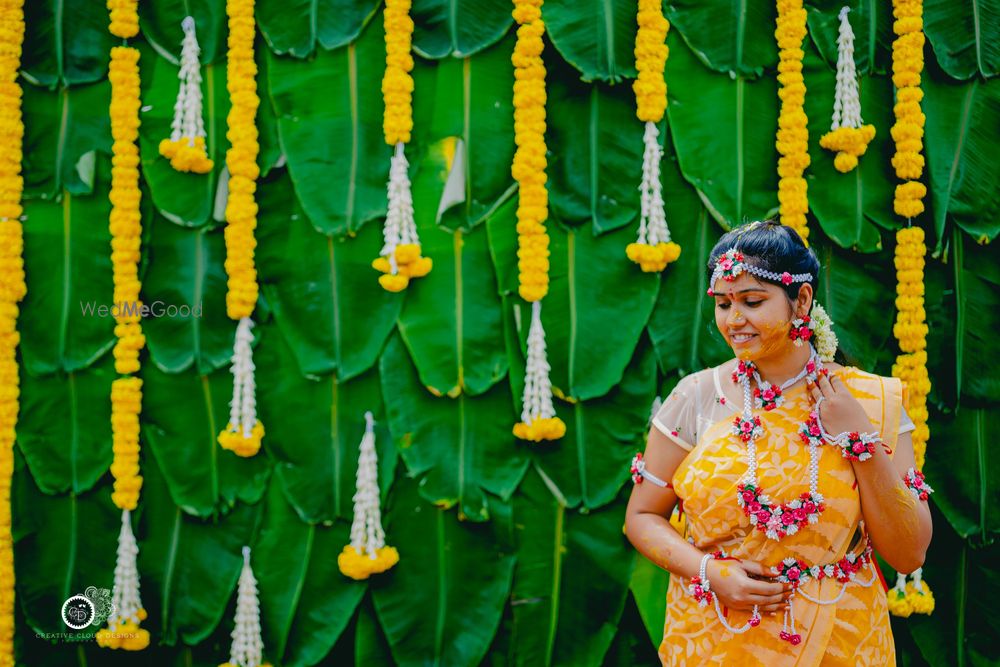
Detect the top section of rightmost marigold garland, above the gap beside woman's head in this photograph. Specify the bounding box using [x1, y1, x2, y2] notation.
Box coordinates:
[892, 0, 927, 218]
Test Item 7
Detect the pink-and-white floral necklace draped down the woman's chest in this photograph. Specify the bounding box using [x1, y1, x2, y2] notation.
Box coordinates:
[732, 346, 826, 540]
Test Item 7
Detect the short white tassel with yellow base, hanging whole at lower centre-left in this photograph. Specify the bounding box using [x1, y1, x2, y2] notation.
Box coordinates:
[337, 412, 399, 579]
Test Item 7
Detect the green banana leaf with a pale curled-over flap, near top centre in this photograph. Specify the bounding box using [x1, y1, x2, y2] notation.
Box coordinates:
[407, 34, 516, 231]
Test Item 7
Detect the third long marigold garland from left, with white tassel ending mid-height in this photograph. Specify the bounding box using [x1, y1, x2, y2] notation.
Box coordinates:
[219, 0, 264, 456]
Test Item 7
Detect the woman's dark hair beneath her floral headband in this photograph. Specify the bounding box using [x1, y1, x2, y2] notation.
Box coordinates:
[708, 220, 819, 301]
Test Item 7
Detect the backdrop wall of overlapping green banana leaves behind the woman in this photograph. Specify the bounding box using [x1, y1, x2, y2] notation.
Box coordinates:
[13, 0, 1000, 666]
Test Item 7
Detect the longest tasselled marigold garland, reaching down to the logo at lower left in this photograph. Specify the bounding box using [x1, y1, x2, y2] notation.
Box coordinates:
[96, 13, 149, 651]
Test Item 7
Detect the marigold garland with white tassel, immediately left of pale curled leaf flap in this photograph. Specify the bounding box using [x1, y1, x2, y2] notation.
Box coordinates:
[372, 0, 433, 292]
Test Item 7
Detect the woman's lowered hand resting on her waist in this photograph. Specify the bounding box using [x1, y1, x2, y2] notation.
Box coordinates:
[706, 558, 792, 616]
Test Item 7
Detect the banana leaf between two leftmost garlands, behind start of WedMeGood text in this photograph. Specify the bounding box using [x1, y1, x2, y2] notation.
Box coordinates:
[18, 163, 115, 376]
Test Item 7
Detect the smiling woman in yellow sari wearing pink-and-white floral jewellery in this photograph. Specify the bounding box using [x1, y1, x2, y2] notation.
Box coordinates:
[625, 222, 932, 667]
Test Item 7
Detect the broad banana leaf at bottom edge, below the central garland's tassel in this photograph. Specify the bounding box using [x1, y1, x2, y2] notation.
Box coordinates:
[510, 470, 634, 667]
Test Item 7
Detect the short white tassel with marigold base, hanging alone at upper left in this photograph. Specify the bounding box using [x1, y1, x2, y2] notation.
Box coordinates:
[160, 16, 214, 174]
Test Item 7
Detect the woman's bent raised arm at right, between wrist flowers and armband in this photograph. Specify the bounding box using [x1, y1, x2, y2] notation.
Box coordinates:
[852, 427, 933, 574]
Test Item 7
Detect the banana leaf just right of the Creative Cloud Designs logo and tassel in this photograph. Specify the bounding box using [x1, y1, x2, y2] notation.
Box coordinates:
[140, 455, 264, 648]
